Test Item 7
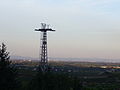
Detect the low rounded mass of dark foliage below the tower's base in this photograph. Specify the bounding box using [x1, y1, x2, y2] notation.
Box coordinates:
[28, 68, 81, 90]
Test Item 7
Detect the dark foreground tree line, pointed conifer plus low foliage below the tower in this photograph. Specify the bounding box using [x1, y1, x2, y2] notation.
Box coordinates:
[0, 43, 82, 90]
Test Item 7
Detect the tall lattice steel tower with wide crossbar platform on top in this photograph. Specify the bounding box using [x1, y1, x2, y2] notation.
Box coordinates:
[35, 23, 55, 72]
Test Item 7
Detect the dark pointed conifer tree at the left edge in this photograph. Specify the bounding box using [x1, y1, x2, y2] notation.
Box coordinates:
[0, 43, 18, 90]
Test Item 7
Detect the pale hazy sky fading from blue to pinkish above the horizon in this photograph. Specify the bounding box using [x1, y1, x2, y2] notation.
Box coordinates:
[0, 0, 120, 59]
